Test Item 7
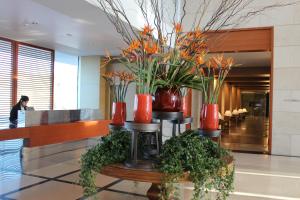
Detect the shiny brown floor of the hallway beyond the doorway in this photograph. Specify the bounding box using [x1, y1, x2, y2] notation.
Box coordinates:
[222, 116, 269, 153]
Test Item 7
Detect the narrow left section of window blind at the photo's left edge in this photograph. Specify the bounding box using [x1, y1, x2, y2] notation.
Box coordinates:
[0, 40, 13, 124]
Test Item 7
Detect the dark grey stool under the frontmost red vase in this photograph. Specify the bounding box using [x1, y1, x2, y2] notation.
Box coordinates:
[124, 121, 160, 169]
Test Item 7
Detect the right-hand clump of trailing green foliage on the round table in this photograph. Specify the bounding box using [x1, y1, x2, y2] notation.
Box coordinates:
[159, 130, 234, 200]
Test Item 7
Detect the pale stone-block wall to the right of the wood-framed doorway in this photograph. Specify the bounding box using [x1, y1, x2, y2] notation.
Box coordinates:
[241, 0, 300, 156]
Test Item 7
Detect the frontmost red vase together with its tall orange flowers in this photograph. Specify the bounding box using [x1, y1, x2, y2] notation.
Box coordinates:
[105, 25, 162, 123]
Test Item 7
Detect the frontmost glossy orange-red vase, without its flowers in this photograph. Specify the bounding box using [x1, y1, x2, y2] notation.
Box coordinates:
[133, 94, 152, 123]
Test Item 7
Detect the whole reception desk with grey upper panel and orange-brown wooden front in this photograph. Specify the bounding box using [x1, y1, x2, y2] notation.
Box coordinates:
[0, 109, 110, 147]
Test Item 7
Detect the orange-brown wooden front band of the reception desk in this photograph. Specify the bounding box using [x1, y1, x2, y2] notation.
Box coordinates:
[0, 120, 111, 147]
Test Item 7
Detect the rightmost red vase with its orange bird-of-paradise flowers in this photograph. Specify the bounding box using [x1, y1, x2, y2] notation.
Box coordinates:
[196, 55, 233, 130]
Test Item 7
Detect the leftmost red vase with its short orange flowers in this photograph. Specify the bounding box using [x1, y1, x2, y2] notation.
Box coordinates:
[102, 71, 134, 126]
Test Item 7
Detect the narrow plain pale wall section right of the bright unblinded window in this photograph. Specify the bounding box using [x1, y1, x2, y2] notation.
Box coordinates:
[78, 56, 100, 109]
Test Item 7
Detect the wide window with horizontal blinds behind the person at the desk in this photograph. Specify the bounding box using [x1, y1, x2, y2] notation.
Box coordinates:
[0, 37, 54, 119]
